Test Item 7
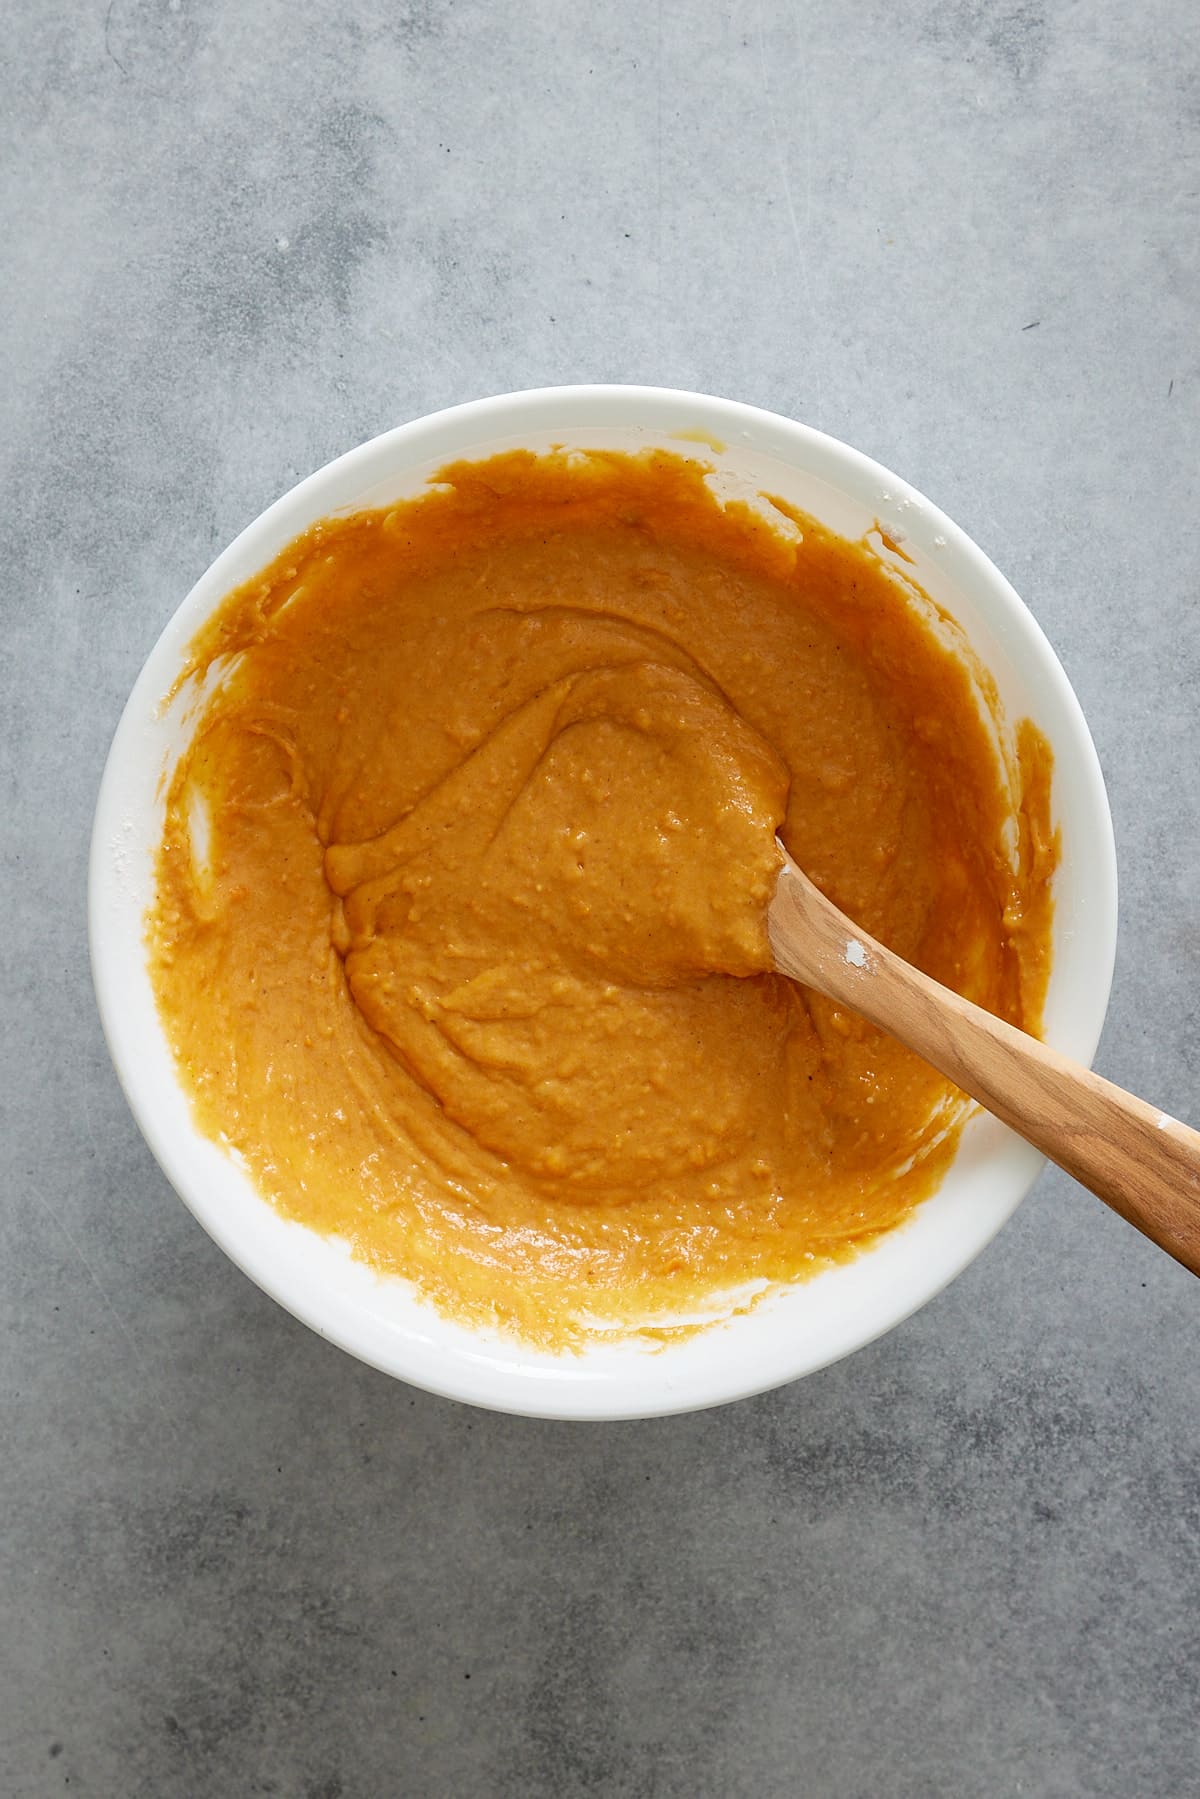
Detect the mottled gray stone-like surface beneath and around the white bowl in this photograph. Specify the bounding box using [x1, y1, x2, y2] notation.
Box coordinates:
[0, 0, 1200, 1799]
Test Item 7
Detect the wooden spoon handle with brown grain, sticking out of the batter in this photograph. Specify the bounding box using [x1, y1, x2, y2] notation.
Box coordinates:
[766, 844, 1200, 1274]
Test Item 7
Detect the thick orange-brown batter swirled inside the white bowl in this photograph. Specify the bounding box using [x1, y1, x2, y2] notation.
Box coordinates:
[149, 453, 1056, 1346]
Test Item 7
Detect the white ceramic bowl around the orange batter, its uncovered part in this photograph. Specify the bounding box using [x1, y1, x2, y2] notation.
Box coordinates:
[88, 387, 1115, 1418]
